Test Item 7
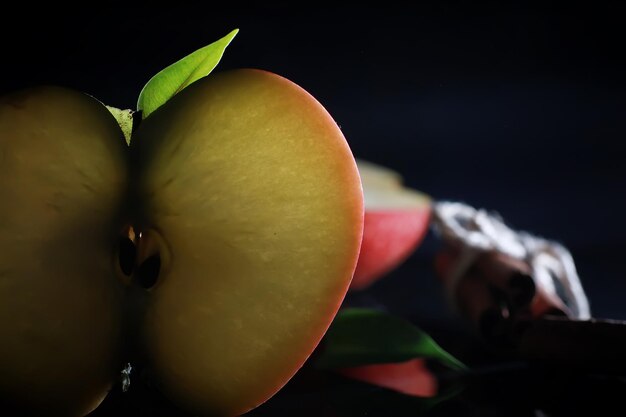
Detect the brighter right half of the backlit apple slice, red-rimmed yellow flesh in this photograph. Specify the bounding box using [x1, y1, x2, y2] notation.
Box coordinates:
[131, 70, 363, 415]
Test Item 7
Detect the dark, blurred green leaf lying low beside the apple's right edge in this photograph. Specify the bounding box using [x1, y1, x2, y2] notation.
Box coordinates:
[316, 308, 467, 371]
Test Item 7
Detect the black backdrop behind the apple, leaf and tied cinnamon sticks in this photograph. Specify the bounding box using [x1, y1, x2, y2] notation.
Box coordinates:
[0, 1, 626, 412]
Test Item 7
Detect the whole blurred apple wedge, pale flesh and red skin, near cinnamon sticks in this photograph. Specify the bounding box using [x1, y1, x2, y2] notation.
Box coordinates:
[350, 160, 431, 290]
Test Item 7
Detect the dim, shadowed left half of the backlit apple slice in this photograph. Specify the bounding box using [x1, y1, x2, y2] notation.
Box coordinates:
[0, 87, 128, 416]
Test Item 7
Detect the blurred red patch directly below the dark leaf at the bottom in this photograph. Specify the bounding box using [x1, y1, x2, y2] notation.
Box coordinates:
[338, 358, 438, 397]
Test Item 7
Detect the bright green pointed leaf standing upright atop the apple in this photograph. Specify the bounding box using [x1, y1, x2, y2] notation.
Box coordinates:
[137, 29, 239, 119]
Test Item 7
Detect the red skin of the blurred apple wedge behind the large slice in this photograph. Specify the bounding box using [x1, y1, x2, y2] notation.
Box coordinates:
[350, 204, 431, 290]
